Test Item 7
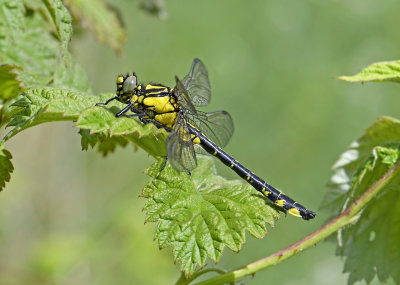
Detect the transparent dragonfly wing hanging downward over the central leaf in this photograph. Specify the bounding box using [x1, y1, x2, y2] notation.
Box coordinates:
[167, 113, 197, 172]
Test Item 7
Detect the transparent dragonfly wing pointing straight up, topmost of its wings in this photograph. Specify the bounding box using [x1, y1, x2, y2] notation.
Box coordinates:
[182, 58, 211, 106]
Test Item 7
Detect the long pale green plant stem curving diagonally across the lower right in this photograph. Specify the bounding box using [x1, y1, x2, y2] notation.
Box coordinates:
[196, 162, 400, 285]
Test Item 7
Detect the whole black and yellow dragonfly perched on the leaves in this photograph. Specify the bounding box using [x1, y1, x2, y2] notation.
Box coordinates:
[98, 59, 316, 220]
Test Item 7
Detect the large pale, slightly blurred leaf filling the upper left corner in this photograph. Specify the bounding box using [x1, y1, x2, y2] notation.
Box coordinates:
[0, 0, 90, 91]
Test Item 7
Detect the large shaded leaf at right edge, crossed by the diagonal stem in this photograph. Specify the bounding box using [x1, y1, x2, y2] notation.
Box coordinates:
[322, 117, 400, 284]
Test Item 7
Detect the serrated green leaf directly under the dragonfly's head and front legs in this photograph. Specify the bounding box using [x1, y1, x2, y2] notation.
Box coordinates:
[76, 105, 167, 158]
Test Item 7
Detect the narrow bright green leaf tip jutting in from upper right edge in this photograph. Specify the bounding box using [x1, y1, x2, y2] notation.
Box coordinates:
[339, 60, 400, 82]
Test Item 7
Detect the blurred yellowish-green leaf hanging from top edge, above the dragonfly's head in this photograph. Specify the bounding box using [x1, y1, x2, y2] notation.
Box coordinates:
[64, 0, 126, 53]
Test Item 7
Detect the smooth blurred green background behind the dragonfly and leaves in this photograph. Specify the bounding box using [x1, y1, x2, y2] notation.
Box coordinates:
[0, 0, 400, 285]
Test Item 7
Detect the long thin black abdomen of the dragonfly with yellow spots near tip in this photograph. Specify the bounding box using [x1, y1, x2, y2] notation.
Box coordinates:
[189, 125, 315, 220]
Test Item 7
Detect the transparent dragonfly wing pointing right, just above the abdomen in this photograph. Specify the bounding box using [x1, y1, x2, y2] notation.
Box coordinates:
[187, 111, 234, 147]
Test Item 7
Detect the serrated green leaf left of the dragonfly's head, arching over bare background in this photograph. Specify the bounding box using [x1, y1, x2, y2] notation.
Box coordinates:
[6, 88, 98, 139]
